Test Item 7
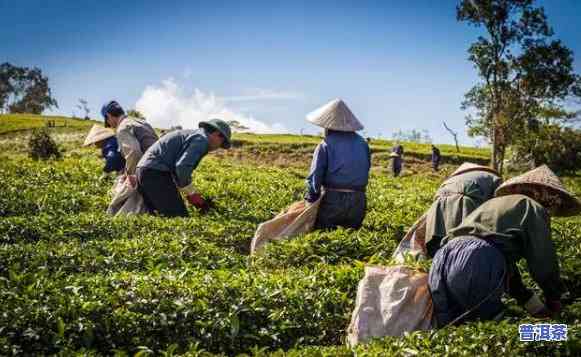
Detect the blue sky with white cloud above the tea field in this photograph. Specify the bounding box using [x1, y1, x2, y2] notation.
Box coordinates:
[0, 0, 581, 143]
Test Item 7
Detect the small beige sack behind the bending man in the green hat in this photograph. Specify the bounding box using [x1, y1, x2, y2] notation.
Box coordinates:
[107, 176, 147, 216]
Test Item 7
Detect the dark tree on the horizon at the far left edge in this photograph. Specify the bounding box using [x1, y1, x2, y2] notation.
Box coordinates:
[0, 63, 58, 114]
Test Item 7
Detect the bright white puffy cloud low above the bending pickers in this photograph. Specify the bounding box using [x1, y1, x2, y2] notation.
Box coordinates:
[135, 78, 288, 133]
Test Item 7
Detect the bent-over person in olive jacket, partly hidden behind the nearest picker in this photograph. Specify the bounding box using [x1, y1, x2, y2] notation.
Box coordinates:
[425, 162, 502, 257]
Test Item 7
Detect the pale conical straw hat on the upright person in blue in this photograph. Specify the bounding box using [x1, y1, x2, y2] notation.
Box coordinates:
[307, 99, 363, 131]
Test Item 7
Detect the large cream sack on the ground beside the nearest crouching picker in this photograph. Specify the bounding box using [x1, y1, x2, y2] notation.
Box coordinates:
[347, 265, 433, 346]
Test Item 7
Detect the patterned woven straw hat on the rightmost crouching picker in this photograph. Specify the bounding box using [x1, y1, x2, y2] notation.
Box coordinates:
[495, 165, 581, 216]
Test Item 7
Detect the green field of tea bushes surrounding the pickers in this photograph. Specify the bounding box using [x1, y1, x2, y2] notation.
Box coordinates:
[0, 118, 581, 356]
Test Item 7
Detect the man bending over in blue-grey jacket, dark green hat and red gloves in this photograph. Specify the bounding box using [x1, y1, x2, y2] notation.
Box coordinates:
[137, 119, 231, 217]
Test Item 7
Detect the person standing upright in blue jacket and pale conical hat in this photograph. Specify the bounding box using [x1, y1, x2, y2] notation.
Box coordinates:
[305, 99, 371, 229]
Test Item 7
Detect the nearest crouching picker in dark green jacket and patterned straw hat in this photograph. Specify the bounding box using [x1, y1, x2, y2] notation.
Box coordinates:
[428, 166, 581, 327]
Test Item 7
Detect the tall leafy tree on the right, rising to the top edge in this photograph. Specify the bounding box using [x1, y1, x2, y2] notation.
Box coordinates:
[456, 0, 581, 172]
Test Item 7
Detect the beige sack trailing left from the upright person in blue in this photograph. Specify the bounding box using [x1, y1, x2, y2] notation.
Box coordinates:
[250, 195, 323, 254]
